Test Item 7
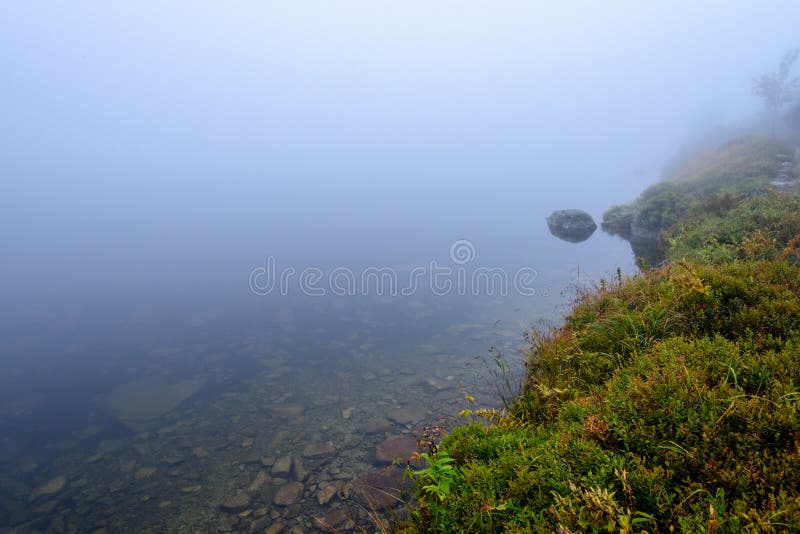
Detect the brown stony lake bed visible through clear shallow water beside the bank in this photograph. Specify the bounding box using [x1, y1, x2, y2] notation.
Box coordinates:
[0, 296, 552, 532]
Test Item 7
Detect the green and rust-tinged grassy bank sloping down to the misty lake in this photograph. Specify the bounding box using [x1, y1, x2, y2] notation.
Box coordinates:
[399, 143, 800, 533]
